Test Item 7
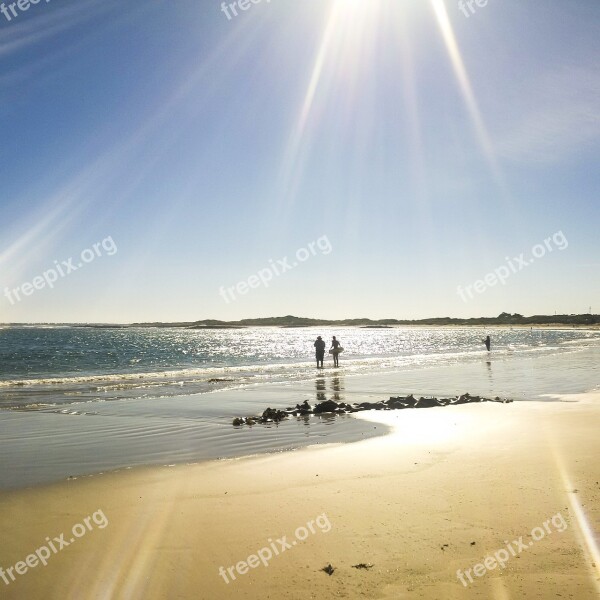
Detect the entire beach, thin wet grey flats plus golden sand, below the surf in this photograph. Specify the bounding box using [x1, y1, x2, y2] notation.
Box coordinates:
[0, 330, 600, 600]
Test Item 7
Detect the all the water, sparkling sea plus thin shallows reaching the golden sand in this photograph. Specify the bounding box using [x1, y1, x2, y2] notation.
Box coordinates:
[0, 326, 600, 489]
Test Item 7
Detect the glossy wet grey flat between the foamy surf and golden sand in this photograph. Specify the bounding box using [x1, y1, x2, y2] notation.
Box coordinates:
[0, 338, 598, 489]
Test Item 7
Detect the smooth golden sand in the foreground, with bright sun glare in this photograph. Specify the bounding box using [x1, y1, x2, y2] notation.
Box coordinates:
[0, 393, 600, 600]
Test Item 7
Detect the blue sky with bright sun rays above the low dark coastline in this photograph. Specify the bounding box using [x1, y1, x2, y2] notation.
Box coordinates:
[0, 0, 600, 323]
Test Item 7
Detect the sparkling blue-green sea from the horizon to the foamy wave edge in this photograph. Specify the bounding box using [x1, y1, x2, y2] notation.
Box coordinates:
[0, 327, 600, 409]
